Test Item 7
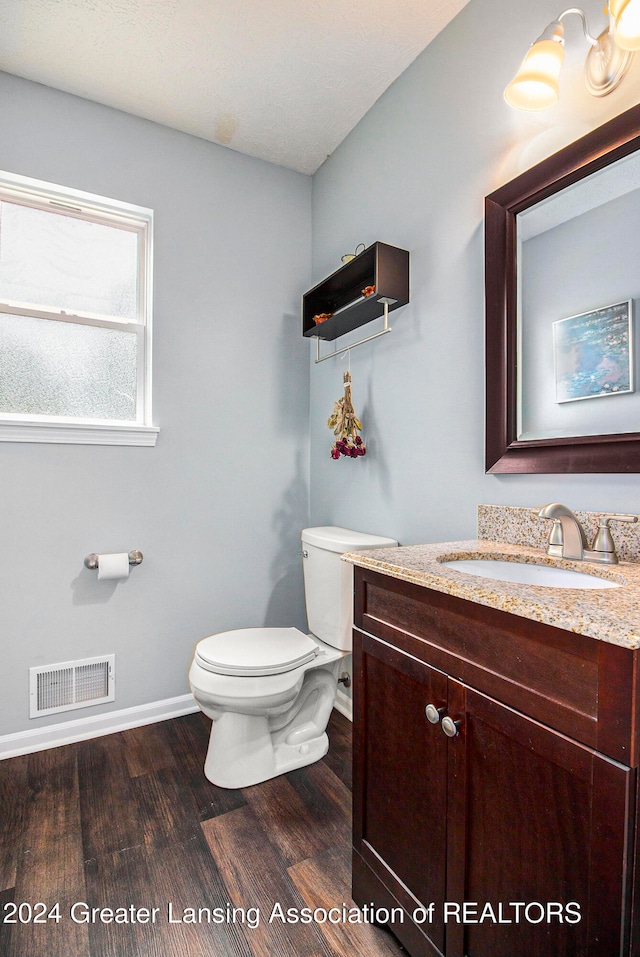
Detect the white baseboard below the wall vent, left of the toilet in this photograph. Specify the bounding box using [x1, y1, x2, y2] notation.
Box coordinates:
[0, 694, 199, 760]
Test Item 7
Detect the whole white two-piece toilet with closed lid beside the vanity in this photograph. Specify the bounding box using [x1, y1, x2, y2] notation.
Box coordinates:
[189, 526, 398, 788]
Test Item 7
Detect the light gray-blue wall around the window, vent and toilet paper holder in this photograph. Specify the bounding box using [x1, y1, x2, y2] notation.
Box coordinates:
[0, 74, 311, 735]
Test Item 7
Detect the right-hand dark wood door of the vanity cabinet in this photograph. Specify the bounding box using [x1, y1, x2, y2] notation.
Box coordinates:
[445, 680, 635, 957]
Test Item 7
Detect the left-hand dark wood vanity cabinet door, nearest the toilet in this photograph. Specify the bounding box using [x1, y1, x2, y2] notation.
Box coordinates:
[354, 633, 447, 955]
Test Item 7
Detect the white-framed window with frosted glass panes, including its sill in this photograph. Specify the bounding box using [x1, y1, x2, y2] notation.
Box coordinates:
[0, 173, 158, 445]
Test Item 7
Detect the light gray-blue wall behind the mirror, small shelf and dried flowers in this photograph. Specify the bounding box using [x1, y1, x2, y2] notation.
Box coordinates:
[311, 0, 640, 543]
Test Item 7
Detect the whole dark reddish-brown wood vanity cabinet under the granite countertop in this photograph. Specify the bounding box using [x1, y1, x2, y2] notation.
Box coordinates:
[353, 568, 640, 957]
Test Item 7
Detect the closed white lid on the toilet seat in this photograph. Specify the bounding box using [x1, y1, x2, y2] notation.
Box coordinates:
[196, 628, 318, 676]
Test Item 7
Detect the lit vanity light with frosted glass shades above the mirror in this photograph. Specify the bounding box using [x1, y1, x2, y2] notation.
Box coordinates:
[504, 0, 640, 110]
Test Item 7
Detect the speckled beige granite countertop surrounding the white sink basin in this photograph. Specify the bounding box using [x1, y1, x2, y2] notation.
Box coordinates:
[343, 539, 640, 648]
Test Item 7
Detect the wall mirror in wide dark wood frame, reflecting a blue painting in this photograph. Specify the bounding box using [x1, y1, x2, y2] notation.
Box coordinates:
[485, 106, 640, 473]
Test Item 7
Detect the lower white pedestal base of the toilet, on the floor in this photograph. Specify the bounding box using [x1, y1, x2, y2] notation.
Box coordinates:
[204, 712, 329, 788]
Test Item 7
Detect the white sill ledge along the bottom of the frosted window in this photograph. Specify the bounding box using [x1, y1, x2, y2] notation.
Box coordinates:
[0, 418, 160, 446]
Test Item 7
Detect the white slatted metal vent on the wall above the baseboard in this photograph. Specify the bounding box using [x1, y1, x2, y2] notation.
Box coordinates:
[29, 655, 116, 718]
